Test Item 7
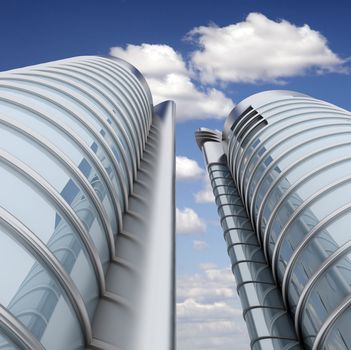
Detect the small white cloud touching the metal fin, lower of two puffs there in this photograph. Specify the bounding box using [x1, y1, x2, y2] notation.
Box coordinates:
[176, 208, 206, 234]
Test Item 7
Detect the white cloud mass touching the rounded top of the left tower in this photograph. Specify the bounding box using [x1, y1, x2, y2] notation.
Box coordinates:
[110, 43, 233, 120]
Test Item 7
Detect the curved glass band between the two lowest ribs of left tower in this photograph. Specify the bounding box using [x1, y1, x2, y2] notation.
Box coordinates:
[0, 223, 84, 350]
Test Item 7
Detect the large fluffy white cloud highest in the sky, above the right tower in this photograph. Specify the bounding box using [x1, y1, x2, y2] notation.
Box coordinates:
[187, 13, 346, 83]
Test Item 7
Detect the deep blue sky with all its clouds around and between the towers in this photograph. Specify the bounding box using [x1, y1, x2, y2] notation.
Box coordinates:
[0, 0, 351, 350]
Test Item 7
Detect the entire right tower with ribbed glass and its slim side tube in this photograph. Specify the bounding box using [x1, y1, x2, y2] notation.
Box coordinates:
[196, 91, 351, 350]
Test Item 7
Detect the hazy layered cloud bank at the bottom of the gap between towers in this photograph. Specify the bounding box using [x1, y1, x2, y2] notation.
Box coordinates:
[177, 264, 249, 350]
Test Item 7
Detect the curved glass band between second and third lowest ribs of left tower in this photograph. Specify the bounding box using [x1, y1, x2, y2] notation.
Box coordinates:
[0, 164, 100, 317]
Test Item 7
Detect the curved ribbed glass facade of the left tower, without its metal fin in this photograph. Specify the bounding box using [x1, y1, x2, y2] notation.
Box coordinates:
[0, 56, 153, 350]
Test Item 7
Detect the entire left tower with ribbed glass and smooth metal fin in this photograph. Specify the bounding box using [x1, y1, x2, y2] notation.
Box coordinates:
[0, 56, 175, 350]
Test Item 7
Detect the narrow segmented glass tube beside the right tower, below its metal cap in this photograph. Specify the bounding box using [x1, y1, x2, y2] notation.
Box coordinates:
[208, 163, 299, 350]
